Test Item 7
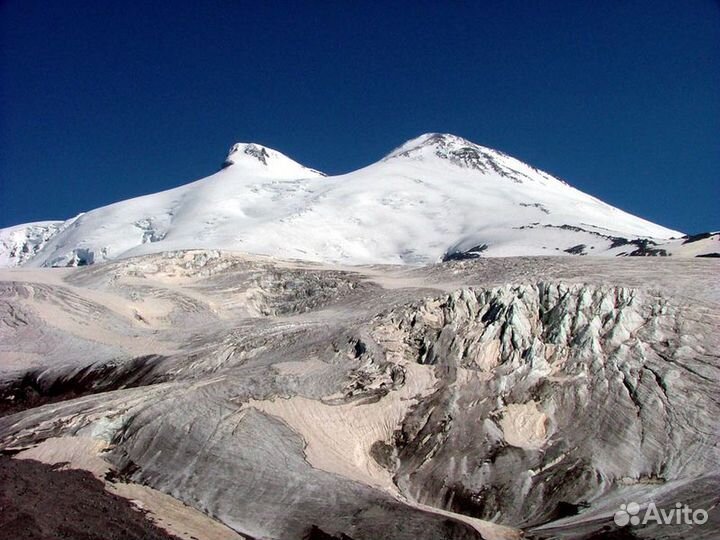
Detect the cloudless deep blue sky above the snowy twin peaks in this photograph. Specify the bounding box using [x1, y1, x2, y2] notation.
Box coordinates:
[0, 0, 720, 232]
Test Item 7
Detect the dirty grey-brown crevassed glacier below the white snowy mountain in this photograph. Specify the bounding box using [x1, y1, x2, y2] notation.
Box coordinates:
[0, 251, 720, 540]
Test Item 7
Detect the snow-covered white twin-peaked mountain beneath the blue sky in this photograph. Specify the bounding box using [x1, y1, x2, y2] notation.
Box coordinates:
[0, 133, 720, 266]
